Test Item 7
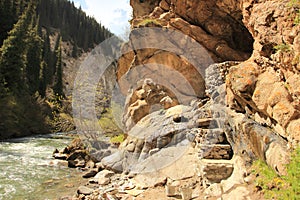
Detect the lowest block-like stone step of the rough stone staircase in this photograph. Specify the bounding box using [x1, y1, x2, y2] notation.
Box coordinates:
[200, 159, 233, 184]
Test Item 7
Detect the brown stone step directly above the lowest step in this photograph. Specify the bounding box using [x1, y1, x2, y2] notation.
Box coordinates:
[199, 144, 233, 160]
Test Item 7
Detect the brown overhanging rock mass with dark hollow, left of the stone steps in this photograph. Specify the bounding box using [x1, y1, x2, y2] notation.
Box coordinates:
[117, 0, 253, 131]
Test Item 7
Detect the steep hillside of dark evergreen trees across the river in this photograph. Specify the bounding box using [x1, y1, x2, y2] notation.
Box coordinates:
[0, 0, 112, 139]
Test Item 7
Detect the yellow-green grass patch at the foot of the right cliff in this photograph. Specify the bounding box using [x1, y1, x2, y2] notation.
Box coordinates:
[252, 147, 300, 200]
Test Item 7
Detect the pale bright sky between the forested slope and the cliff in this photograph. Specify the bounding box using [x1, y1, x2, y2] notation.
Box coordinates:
[71, 0, 132, 36]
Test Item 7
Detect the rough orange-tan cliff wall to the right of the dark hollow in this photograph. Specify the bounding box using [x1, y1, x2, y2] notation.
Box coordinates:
[227, 1, 300, 144]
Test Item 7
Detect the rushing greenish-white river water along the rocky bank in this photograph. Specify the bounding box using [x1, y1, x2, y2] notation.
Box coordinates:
[0, 134, 82, 200]
